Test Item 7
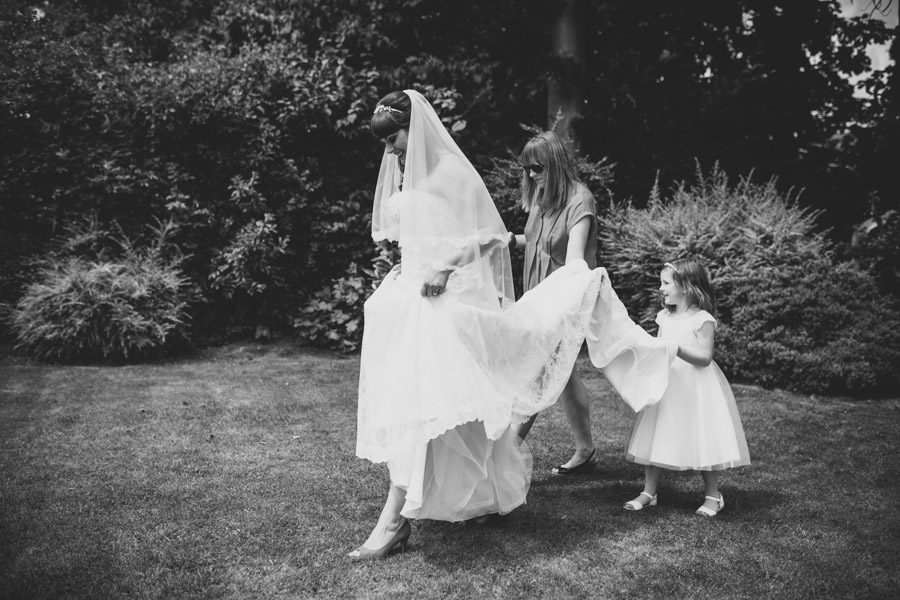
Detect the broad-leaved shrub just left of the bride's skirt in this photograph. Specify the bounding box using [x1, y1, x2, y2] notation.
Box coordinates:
[294, 242, 399, 352]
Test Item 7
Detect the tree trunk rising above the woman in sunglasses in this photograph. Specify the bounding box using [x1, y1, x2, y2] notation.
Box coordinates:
[547, 0, 585, 154]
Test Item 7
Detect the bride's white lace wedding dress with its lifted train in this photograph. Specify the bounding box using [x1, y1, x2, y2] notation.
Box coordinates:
[357, 192, 670, 521]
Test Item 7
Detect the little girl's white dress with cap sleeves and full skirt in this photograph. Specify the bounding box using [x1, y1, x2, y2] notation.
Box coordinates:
[626, 309, 750, 471]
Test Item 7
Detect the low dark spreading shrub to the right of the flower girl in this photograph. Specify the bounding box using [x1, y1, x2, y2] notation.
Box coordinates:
[717, 257, 900, 396]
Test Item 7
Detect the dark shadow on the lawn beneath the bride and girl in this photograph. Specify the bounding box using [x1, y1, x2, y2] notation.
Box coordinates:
[386, 468, 786, 573]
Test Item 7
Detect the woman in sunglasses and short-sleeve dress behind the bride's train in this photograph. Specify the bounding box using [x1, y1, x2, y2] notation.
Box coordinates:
[510, 131, 597, 475]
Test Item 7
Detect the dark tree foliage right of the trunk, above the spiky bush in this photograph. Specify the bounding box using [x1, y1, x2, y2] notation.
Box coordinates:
[579, 0, 897, 235]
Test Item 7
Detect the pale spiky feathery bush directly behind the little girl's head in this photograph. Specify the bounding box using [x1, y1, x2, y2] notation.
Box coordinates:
[599, 164, 828, 325]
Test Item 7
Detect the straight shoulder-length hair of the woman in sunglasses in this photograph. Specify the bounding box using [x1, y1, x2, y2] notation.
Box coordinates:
[519, 131, 581, 210]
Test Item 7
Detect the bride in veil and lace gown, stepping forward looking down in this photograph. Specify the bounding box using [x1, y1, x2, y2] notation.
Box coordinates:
[350, 90, 670, 559]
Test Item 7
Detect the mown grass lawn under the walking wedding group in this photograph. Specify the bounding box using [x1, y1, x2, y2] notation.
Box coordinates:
[0, 345, 900, 600]
